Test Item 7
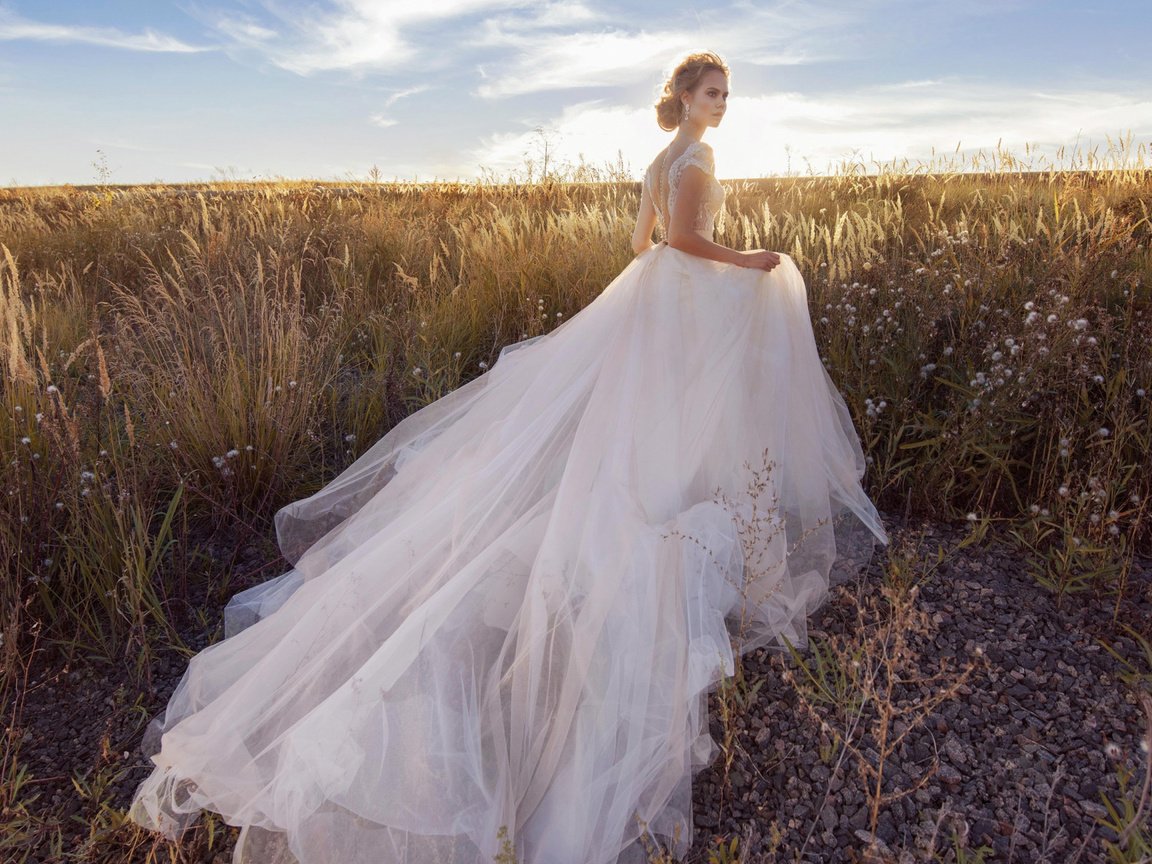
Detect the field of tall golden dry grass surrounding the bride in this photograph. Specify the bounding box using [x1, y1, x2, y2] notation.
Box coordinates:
[0, 140, 1152, 862]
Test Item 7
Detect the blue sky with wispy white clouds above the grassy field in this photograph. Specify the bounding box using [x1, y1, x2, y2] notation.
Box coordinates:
[0, 0, 1152, 185]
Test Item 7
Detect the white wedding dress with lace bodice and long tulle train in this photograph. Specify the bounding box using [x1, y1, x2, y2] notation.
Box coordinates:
[129, 142, 887, 864]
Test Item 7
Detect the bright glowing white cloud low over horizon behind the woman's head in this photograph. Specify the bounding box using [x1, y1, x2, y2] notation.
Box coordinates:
[462, 79, 1152, 179]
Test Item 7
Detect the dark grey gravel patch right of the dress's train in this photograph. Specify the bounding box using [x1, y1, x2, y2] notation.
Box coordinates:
[692, 518, 1152, 864]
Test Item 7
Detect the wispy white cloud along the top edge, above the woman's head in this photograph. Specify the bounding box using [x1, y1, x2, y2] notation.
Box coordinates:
[198, 0, 847, 83]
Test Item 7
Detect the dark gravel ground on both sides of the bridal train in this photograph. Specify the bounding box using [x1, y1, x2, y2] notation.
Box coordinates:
[5, 518, 1152, 864]
